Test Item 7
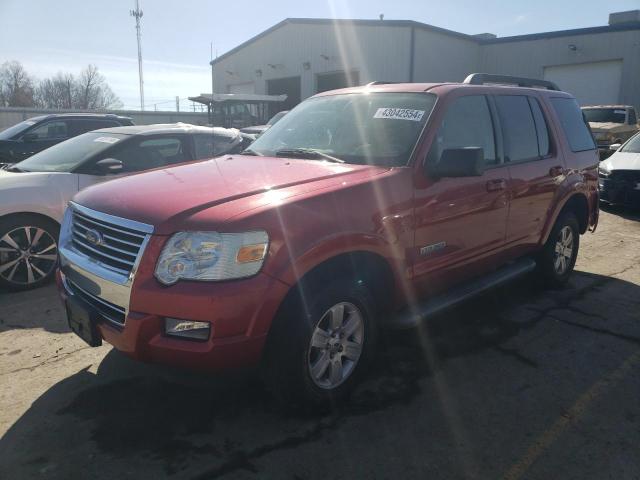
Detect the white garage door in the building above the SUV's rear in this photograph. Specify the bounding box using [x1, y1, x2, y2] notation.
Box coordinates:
[544, 60, 622, 105]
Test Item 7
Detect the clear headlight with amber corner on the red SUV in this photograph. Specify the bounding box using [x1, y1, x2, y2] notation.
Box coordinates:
[155, 231, 269, 285]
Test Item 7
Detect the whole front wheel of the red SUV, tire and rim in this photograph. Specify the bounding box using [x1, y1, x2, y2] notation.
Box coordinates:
[263, 280, 377, 411]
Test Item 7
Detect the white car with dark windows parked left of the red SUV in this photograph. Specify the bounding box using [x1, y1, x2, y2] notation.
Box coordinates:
[0, 124, 248, 290]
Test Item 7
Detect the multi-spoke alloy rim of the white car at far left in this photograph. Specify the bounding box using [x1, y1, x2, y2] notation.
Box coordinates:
[0, 226, 58, 286]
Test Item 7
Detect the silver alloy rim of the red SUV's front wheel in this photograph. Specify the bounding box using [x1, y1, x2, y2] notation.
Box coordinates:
[308, 302, 364, 390]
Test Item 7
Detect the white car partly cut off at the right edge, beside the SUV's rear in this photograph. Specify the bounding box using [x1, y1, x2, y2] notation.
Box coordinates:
[598, 133, 640, 207]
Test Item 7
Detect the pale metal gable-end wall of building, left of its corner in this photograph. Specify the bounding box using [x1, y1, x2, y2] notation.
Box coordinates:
[214, 24, 411, 99]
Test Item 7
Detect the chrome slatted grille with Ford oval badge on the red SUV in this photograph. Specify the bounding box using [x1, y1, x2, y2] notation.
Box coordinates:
[71, 209, 146, 275]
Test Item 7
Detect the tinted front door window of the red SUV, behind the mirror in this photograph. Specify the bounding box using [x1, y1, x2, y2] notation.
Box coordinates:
[428, 95, 497, 164]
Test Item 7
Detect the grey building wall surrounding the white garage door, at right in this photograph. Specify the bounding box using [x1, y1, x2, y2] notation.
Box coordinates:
[480, 30, 640, 107]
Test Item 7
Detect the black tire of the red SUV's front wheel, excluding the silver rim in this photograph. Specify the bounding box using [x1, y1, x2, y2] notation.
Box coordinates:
[262, 279, 377, 412]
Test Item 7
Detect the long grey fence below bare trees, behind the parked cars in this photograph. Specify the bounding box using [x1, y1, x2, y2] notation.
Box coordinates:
[0, 107, 208, 131]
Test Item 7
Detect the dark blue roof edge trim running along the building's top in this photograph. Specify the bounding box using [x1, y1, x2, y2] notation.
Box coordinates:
[209, 18, 640, 65]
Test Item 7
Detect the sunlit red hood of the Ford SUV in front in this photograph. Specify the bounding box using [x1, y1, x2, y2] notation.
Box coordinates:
[73, 155, 389, 234]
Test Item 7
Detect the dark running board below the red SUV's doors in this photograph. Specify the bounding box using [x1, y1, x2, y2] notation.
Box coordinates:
[389, 258, 536, 329]
